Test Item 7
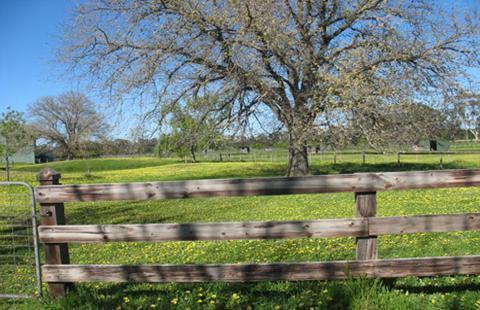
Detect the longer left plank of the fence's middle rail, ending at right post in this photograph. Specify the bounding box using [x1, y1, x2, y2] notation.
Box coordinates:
[39, 219, 368, 243]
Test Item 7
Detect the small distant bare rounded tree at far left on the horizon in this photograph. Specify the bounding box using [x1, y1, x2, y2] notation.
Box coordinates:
[29, 92, 107, 159]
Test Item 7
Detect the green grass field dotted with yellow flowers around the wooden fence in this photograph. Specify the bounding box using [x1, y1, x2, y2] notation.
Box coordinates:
[0, 155, 480, 309]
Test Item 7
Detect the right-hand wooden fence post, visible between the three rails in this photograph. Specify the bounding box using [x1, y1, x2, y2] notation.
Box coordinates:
[355, 192, 377, 260]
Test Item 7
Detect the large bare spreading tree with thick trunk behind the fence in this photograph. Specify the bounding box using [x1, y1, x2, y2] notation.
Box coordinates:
[59, 0, 479, 175]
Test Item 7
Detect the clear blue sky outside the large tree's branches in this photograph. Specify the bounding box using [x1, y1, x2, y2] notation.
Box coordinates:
[0, 0, 480, 134]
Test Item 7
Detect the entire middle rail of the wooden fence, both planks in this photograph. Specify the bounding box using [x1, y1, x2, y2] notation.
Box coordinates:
[39, 213, 480, 243]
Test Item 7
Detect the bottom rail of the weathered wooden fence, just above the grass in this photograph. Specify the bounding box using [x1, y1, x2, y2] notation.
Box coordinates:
[42, 256, 480, 282]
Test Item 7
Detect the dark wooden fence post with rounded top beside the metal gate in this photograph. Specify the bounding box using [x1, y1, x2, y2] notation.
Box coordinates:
[37, 168, 72, 297]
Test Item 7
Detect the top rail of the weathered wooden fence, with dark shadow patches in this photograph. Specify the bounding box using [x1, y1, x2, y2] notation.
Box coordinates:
[35, 169, 480, 203]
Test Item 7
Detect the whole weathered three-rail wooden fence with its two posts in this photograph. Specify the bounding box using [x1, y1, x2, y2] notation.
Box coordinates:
[35, 168, 480, 296]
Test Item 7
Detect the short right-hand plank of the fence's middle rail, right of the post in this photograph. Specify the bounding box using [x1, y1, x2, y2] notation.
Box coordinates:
[368, 213, 480, 235]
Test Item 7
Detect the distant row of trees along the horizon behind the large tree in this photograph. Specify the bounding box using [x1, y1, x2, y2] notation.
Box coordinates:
[0, 88, 480, 162]
